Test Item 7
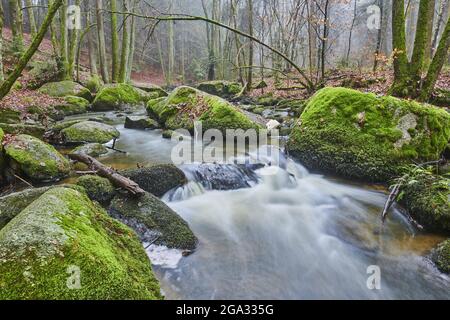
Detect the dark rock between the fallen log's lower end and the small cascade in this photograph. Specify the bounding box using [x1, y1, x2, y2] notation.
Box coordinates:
[120, 164, 187, 197]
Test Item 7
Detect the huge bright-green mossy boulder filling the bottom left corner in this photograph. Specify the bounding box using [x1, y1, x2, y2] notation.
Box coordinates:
[0, 188, 161, 299]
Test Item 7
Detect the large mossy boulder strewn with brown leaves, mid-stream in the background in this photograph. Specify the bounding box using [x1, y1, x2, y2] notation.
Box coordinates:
[147, 87, 260, 132]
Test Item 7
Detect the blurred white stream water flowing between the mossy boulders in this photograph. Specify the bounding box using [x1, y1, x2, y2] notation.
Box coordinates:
[76, 112, 450, 299]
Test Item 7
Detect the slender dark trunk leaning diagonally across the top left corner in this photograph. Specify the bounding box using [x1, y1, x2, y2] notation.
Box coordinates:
[0, 0, 62, 99]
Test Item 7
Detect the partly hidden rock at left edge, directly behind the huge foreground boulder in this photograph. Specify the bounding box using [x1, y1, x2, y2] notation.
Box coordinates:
[0, 185, 81, 229]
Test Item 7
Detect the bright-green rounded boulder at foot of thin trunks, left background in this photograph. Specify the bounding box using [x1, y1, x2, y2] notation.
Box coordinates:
[92, 83, 150, 111]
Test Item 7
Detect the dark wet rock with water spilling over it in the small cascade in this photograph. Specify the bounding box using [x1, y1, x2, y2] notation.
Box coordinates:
[183, 163, 258, 190]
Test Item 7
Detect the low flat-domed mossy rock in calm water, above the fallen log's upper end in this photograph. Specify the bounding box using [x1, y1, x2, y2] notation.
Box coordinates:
[61, 121, 120, 144]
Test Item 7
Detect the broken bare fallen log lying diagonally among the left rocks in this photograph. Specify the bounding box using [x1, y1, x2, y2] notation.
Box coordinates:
[69, 153, 145, 196]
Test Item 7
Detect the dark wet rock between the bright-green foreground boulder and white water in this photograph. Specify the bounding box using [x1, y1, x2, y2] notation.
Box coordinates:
[109, 193, 197, 250]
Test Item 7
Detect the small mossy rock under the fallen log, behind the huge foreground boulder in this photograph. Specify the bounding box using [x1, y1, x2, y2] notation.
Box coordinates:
[77, 175, 116, 203]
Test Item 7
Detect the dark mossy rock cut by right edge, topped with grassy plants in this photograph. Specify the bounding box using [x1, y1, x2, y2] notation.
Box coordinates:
[399, 173, 450, 233]
